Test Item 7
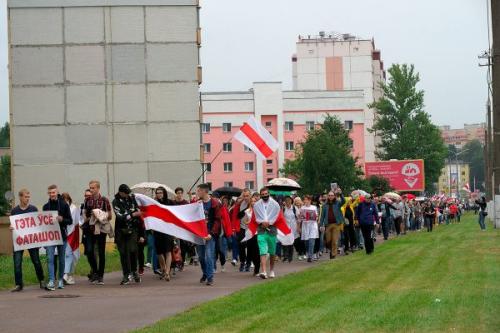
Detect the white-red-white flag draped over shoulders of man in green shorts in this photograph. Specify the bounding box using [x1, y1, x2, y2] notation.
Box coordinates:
[242, 199, 295, 245]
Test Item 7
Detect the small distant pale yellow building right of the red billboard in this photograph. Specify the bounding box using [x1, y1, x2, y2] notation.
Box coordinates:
[438, 161, 474, 197]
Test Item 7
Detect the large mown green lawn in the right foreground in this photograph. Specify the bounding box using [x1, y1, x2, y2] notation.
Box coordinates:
[138, 215, 500, 333]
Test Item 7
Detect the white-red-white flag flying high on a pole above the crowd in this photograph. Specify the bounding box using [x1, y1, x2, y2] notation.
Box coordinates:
[234, 116, 279, 160]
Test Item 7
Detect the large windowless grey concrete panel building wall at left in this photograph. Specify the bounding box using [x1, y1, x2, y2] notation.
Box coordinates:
[8, 0, 201, 204]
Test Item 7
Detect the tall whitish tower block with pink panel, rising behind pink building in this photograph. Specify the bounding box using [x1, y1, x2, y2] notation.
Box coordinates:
[292, 32, 385, 161]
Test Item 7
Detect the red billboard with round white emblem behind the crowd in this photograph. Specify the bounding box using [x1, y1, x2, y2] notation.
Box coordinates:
[365, 160, 425, 192]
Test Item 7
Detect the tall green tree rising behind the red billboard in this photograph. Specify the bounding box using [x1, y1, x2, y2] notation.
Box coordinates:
[369, 64, 448, 191]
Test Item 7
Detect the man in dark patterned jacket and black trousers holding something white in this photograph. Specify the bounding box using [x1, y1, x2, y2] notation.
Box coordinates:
[83, 180, 113, 285]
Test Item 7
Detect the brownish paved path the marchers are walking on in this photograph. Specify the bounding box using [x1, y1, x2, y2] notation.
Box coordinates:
[0, 256, 338, 333]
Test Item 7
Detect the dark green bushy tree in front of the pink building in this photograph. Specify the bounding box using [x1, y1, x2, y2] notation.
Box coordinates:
[280, 115, 363, 194]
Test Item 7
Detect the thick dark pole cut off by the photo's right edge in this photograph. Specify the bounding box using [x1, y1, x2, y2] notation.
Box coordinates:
[490, 0, 500, 227]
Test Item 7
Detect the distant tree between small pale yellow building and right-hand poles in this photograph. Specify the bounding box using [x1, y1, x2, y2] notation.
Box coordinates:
[458, 140, 485, 191]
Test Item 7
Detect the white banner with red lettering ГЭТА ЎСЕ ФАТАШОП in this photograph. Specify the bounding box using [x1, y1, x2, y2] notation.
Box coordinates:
[10, 211, 64, 250]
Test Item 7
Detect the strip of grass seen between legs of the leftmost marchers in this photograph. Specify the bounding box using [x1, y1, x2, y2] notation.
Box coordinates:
[0, 245, 121, 290]
